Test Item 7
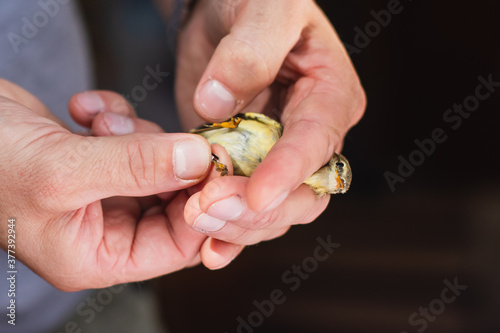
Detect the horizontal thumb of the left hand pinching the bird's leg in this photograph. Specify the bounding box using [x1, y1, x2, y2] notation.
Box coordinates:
[39, 133, 211, 211]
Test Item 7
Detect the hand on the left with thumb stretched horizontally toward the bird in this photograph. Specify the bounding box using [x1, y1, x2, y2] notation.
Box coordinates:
[0, 80, 215, 291]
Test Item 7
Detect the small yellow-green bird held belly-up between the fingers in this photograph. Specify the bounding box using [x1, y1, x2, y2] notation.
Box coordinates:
[190, 112, 352, 196]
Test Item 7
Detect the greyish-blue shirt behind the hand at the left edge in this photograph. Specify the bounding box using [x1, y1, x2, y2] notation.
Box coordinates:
[0, 0, 92, 333]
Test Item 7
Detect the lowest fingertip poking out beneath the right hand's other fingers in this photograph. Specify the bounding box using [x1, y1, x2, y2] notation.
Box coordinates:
[200, 238, 245, 270]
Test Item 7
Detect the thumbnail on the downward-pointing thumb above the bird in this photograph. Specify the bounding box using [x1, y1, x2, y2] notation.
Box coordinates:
[196, 80, 236, 118]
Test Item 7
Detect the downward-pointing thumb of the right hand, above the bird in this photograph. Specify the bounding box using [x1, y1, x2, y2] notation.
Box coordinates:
[194, 0, 310, 121]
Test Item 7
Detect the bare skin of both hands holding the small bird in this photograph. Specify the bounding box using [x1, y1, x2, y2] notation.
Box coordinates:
[0, 0, 365, 290]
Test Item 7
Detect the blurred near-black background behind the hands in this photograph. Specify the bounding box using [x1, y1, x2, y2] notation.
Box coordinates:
[82, 0, 500, 333]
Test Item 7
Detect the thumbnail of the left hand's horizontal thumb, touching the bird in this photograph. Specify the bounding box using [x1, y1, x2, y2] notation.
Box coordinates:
[173, 140, 211, 180]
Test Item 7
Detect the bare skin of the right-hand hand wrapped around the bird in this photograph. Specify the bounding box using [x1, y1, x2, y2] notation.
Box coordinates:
[74, 0, 366, 269]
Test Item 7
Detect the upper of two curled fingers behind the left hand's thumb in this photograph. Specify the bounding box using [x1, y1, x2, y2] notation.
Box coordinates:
[68, 90, 137, 128]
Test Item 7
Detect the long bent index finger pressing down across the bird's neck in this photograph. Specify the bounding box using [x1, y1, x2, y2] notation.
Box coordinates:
[244, 10, 366, 212]
